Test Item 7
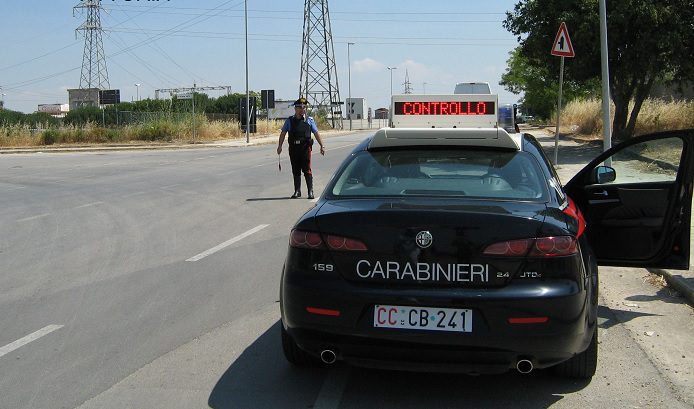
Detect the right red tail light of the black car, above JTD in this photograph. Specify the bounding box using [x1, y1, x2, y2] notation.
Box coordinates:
[483, 236, 578, 257]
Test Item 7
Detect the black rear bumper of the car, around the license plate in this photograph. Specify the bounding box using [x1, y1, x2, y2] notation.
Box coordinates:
[281, 277, 597, 373]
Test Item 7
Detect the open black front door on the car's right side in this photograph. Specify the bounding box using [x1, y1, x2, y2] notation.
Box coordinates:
[564, 130, 694, 270]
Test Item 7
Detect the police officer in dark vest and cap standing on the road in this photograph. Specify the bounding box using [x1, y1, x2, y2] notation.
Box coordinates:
[277, 97, 325, 199]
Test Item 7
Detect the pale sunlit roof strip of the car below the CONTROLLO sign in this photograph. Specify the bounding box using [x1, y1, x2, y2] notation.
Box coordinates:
[367, 128, 520, 150]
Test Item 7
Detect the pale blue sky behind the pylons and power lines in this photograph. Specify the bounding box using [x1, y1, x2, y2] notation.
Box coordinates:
[0, 0, 520, 112]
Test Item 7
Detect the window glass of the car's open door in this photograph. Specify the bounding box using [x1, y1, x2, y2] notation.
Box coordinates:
[606, 137, 683, 184]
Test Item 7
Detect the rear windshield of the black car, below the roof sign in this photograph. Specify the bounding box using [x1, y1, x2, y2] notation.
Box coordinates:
[330, 149, 548, 201]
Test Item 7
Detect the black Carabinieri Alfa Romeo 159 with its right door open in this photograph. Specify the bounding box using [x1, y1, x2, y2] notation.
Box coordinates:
[280, 128, 694, 378]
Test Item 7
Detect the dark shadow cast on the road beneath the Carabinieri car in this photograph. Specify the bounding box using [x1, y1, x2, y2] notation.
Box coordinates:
[208, 321, 589, 409]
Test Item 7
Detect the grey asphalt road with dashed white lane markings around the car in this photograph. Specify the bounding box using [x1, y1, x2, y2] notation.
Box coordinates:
[0, 133, 694, 409]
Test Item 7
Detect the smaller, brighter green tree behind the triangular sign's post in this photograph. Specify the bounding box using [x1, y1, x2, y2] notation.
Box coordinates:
[499, 47, 600, 119]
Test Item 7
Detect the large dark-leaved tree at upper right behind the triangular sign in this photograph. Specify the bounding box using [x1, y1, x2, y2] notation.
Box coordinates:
[504, 0, 694, 139]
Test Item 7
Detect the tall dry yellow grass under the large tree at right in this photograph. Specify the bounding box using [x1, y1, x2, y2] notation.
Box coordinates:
[561, 99, 694, 138]
